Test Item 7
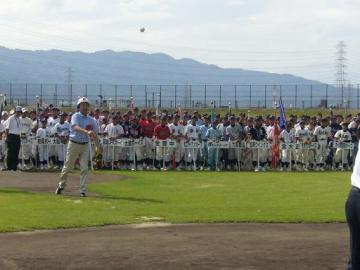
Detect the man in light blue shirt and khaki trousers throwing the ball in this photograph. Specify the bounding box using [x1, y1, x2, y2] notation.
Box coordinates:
[55, 97, 99, 197]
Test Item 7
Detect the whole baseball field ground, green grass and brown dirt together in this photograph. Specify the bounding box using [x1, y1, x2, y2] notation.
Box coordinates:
[0, 171, 350, 269]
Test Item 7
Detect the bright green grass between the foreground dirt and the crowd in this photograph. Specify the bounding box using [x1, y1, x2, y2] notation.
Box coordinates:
[0, 172, 350, 232]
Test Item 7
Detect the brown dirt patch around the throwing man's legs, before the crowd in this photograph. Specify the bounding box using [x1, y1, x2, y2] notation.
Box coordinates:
[0, 171, 127, 196]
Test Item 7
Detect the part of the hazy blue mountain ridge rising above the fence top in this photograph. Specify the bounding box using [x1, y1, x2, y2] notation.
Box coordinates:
[0, 47, 319, 84]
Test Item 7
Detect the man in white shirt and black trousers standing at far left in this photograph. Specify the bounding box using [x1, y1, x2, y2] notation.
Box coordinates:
[5, 106, 22, 171]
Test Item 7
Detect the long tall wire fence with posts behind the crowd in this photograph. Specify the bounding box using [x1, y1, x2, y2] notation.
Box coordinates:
[0, 83, 360, 109]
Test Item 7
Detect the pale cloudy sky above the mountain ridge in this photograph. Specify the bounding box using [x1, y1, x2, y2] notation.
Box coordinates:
[0, 0, 360, 83]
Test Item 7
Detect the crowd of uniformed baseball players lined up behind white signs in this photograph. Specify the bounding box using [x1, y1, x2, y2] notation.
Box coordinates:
[0, 105, 360, 171]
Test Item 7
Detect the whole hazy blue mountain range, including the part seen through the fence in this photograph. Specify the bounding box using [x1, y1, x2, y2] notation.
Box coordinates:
[0, 47, 348, 107]
